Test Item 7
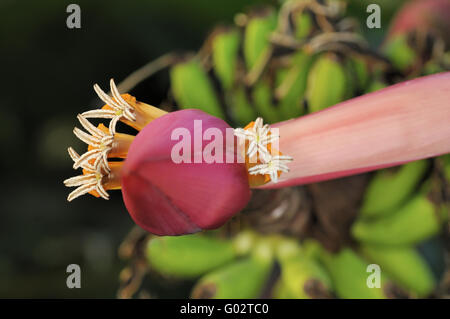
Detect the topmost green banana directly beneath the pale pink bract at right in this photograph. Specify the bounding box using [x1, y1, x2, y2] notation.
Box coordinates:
[361, 160, 429, 218]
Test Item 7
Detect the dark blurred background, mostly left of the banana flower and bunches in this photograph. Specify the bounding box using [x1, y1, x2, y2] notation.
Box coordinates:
[0, 0, 402, 298]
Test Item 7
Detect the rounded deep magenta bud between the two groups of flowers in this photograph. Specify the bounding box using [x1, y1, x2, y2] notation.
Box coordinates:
[122, 110, 251, 235]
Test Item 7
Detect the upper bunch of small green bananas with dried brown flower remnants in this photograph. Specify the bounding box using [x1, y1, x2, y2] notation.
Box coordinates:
[170, 0, 383, 125]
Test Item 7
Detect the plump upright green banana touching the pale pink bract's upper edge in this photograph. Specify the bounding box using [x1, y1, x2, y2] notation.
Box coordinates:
[306, 54, 349, 112]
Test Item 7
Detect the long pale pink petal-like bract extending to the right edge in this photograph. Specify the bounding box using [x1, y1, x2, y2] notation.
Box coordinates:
[263, 72, 450, 188]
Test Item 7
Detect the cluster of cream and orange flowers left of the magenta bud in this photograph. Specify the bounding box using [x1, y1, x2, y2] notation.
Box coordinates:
[64, 79, 167, 201]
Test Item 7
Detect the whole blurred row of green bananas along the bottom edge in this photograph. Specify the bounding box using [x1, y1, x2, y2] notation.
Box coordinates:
[145, 212, 445, 299]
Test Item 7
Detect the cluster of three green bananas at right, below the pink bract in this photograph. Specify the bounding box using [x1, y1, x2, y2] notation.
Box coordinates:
[351, 160, 449, 297]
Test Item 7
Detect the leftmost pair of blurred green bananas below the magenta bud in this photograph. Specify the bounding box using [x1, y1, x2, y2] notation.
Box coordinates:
[146, 232, 273, 298]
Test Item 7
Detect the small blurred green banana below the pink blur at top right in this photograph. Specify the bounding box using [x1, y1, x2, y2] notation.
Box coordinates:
[383, 34, 417, 71]
